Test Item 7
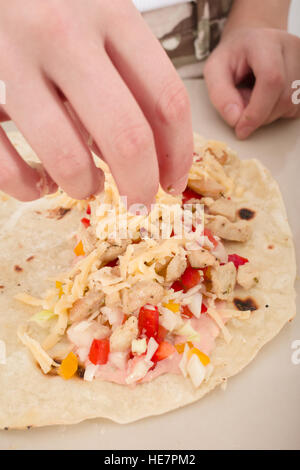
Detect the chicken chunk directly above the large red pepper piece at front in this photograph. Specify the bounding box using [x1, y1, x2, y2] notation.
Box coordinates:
[123, 281, 164, 313]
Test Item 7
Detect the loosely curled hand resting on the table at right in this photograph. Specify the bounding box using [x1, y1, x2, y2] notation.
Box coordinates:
[204, 28, 300, 139]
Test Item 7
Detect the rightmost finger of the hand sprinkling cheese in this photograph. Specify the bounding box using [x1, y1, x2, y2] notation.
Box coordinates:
[106, 5, 193, 193]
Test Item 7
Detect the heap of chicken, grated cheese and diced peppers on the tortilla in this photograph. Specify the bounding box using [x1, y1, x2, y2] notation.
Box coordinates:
[17, 138, 260, 388]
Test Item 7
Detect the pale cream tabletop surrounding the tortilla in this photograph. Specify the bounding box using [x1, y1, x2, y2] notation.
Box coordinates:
[0, 80, 300, 450]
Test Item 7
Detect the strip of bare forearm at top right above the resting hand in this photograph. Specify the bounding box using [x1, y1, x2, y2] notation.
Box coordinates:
[223, 0, 291, 36]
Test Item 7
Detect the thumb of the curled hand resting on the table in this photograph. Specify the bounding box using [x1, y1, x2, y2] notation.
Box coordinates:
[204, 54, 245, 127]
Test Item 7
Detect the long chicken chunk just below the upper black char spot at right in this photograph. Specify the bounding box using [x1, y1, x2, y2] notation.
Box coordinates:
[205, 215, 252, 242]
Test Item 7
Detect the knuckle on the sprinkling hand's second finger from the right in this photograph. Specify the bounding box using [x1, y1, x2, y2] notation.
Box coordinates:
[114, 124, 153, 159]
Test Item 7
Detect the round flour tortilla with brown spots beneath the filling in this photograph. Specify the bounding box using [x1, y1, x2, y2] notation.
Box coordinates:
[0, 135, 296, 428]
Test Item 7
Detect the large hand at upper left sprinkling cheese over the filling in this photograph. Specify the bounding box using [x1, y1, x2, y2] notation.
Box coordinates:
[0, 0, 193, 205]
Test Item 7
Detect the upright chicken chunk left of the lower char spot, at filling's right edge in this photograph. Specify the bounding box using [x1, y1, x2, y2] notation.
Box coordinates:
[211, 262, 236, 299]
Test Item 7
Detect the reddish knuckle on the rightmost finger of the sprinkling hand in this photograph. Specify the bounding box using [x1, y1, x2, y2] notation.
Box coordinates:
[156, 80, 190, 125]
